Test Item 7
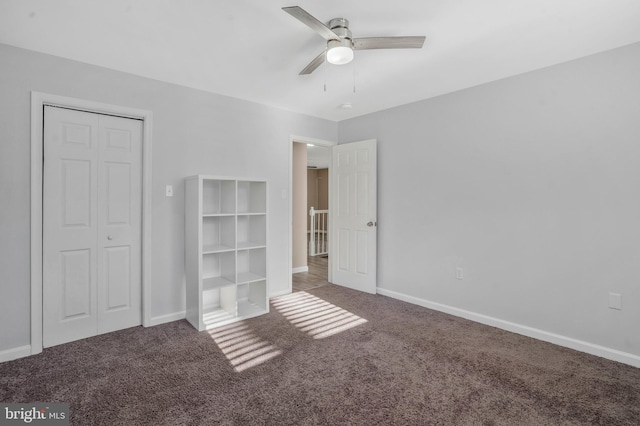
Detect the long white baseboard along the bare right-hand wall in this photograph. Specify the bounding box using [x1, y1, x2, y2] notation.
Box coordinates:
[377, 287, 640, 368]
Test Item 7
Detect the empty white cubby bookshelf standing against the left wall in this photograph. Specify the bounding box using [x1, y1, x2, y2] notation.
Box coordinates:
[185, 175, 269, 331]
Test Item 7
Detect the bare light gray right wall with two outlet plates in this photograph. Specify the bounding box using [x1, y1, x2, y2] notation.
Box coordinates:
[338, 44, 640, 355]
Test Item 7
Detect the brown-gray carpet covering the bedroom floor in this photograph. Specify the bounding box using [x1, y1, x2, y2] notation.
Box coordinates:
[0, 285, 640, 425]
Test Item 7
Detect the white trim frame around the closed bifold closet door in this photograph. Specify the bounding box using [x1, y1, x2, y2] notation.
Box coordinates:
[31, 91, 153, 355]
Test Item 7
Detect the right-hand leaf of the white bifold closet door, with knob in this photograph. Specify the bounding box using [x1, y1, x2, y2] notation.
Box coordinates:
[97, 116, 142, 334]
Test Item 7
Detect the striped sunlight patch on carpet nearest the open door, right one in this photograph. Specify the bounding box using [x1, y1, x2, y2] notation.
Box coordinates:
[271, 291, 367, 339]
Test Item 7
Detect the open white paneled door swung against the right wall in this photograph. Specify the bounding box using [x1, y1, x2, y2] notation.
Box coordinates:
[330, 139, 377, 293]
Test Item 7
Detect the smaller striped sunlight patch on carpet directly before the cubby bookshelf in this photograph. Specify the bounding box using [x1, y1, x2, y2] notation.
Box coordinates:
[208, 322, 282, 373]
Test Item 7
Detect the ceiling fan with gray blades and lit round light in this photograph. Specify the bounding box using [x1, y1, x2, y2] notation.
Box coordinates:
[282, 6, 425, 75]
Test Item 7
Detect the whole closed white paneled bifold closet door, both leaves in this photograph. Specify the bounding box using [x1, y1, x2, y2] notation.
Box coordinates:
[42, 106, 142, 347]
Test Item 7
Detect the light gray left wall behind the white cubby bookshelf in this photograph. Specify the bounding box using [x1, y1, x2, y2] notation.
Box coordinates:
[0, 45, 337, 351]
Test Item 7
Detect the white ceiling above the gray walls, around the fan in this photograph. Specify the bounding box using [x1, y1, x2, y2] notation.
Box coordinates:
[0, 0, 640, 121]
